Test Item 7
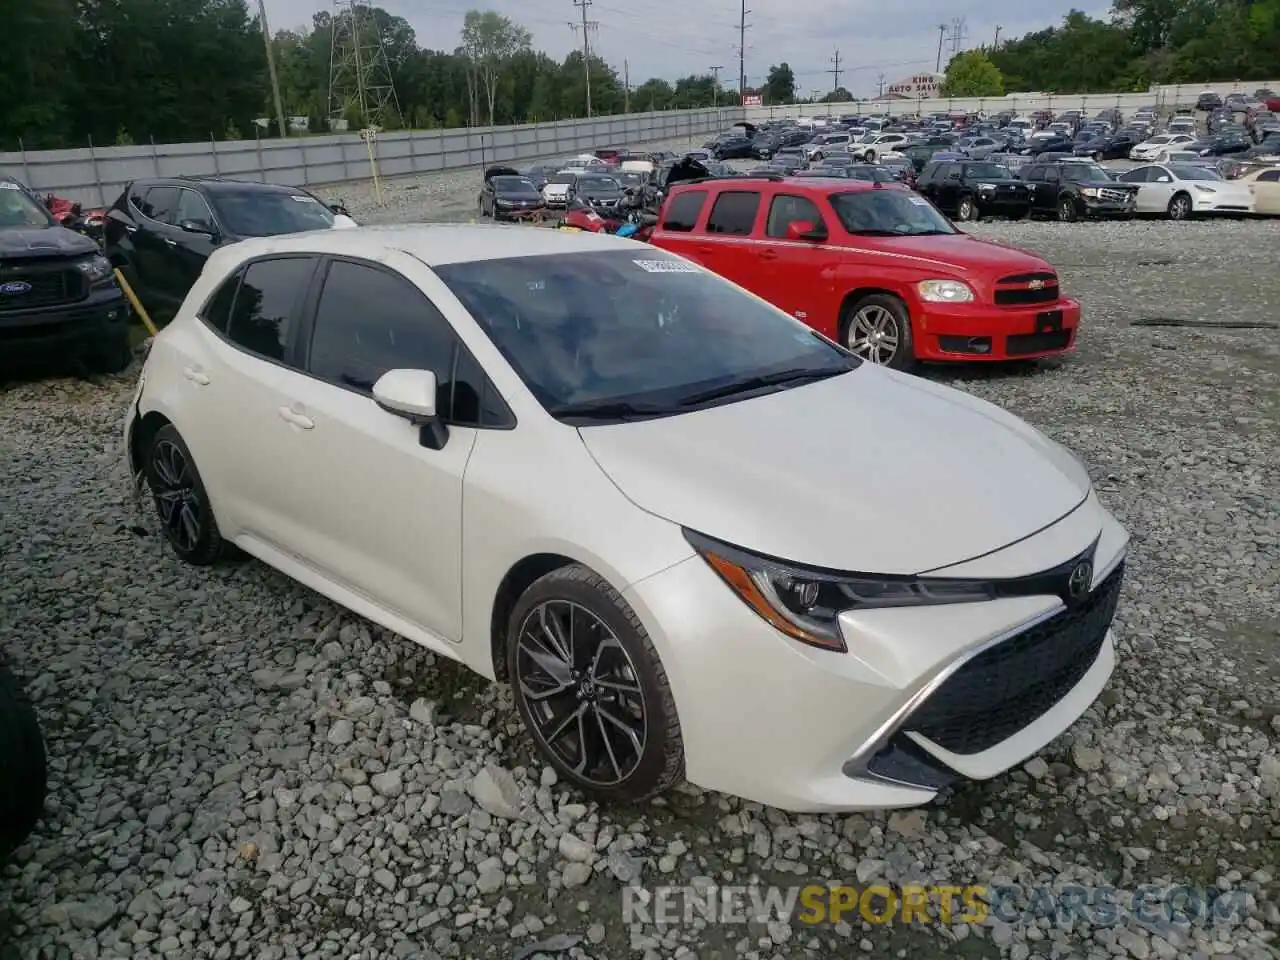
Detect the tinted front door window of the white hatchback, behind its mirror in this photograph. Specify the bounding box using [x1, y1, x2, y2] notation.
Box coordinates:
[307, 260, 511, 426]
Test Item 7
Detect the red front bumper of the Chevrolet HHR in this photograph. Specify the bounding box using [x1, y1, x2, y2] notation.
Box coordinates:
[911, 297, 1080, 362]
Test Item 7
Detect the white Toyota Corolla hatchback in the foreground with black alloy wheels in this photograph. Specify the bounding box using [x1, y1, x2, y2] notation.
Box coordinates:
[125, 225, 1128, 810]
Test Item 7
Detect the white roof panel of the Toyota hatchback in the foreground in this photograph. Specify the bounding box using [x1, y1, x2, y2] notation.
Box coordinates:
[215, 224, 648, 266]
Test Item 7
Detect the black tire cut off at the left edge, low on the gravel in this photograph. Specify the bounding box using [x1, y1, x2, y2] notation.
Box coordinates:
[0, 657, 49, 861]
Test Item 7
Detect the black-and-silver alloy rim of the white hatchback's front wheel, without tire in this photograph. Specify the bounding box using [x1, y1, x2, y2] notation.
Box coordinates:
[513, 600, 648, 787]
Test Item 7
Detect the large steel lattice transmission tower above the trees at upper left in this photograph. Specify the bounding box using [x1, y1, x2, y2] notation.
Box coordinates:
[329, 0, 399, 127]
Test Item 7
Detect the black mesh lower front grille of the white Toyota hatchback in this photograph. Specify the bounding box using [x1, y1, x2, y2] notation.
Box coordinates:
[904, 563, 1124, 754]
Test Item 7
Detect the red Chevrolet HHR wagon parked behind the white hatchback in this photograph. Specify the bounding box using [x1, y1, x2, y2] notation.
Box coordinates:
[652, 175, 1080, 370]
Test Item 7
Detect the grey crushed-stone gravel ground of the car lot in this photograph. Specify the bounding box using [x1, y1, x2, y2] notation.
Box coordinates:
[0, 175, 1280, 960]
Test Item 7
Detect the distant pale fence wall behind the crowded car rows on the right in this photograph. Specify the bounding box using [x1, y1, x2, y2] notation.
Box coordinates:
[746, 79, 1280, 123]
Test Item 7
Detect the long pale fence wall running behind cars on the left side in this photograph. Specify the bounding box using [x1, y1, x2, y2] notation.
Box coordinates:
[0, 106, 742, 206]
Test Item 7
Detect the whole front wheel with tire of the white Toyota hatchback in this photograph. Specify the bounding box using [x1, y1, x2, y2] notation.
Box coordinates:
[506, 563, 685, 803]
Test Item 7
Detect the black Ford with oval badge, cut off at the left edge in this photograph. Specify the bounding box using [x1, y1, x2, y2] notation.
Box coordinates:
[0, 177, 132, 374]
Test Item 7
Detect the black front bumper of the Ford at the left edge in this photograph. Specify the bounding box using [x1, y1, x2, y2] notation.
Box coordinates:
[0, 284, 129, 361]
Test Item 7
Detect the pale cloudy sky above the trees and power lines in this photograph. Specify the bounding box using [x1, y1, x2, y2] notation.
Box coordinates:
[266, 0, 1108, 96]
